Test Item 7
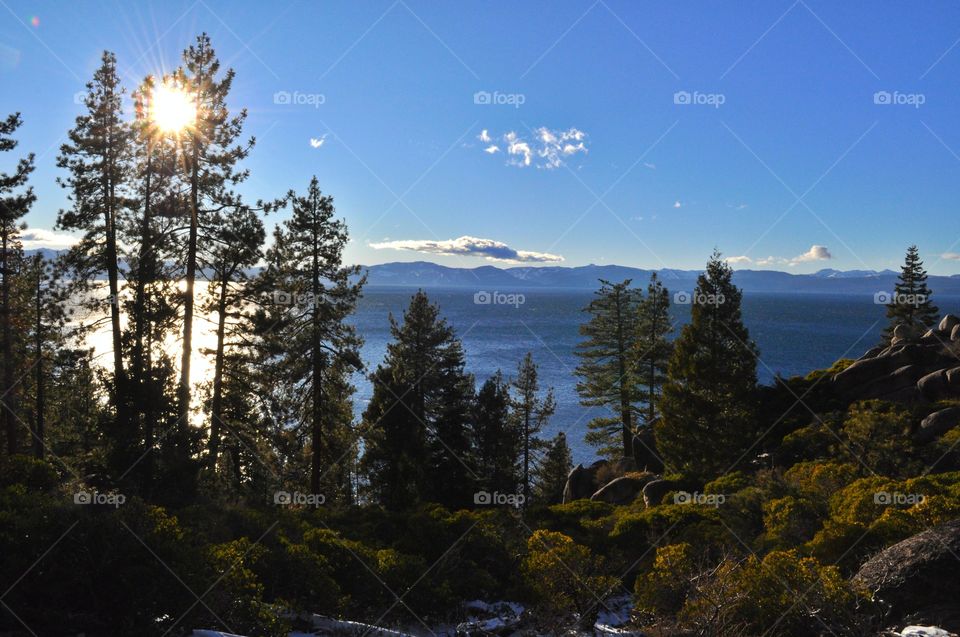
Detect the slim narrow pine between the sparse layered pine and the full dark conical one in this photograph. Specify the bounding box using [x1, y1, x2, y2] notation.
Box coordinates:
[632, 273, 673, 427]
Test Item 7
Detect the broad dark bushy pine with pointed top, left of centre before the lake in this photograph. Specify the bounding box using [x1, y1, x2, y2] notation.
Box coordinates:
[361, 290, 474, 510]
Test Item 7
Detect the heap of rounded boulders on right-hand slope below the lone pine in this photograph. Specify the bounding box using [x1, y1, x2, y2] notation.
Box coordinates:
[833, 314, 960, 402]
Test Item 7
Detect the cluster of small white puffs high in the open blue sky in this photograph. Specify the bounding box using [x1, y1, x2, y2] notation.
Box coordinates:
[477, 126, 589, 170]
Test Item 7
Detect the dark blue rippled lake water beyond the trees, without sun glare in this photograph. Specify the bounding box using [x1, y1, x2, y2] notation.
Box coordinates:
[354, 287, 960, 462]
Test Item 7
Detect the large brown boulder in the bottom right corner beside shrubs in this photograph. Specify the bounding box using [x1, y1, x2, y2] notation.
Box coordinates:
[853, 519, 960, 631]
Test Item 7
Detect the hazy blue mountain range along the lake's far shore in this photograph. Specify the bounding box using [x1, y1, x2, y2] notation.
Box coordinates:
[364, 261, 960, 295]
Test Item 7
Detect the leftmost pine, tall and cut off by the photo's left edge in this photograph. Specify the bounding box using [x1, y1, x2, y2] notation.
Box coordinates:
[0, 113, 36, 455]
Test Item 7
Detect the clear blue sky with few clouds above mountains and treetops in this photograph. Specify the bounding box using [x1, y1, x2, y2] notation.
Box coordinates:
[0, 0, 960, 274]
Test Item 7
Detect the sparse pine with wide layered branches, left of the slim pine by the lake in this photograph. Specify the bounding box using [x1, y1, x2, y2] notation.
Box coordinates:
[576, 279, 643, 457]
